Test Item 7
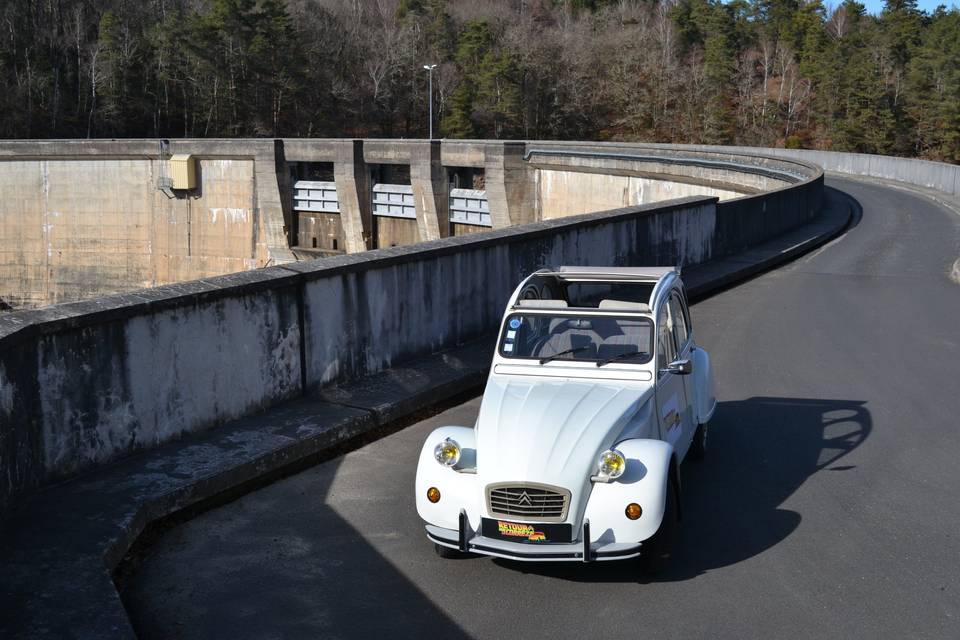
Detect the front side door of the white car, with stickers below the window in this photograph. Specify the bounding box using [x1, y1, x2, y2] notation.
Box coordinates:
[656, 290, 693, 460]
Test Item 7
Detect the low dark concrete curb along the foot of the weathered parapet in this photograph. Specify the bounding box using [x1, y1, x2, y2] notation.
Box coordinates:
[0, 189, 854, 638]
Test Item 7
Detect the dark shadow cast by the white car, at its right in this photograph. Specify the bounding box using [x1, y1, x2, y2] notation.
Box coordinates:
[496, 397, 872, 582]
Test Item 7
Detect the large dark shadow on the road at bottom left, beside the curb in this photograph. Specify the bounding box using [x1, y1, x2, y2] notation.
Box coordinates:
[121, 450, 470, 640]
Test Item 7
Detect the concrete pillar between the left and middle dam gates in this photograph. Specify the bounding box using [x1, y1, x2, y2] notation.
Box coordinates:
[333, 140, 373, 253]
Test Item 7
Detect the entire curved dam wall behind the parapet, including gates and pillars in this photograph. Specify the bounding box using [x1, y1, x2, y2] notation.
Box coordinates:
[0, 139, 810, 309]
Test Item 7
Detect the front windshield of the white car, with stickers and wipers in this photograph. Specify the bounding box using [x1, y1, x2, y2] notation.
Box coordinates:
[500, 313, 653, 365]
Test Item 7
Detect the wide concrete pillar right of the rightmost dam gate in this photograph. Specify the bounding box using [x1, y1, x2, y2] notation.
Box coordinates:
[483, 142, 537, 229]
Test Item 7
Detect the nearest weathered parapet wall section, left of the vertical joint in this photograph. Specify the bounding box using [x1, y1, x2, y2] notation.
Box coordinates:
[0, 268, 302, 506]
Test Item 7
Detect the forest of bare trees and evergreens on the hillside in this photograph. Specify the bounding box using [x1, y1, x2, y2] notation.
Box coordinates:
[0, 0, 960, 162]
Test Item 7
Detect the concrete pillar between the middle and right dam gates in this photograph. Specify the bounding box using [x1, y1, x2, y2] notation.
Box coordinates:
[410, 140, 450, 240]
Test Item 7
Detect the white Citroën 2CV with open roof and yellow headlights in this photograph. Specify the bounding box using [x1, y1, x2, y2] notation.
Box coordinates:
[416, 267, 716, 572]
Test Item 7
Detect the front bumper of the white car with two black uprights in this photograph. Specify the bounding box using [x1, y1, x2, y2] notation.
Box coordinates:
[426, 515, 641, 562]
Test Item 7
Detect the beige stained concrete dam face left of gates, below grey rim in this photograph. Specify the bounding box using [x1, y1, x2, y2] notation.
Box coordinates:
[0, 159, 266, 307]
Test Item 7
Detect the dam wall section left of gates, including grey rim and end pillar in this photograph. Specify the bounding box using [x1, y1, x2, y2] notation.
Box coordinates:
[0, 140, 290, 308]
